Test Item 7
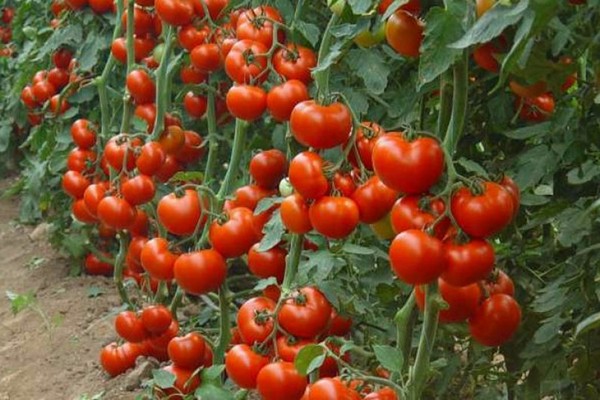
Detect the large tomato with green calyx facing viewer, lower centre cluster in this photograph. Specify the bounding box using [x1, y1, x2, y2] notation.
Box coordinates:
[277, 287, 331, 339]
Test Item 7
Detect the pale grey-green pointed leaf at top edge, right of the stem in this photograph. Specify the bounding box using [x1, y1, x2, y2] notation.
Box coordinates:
[450, 0, 529, 49]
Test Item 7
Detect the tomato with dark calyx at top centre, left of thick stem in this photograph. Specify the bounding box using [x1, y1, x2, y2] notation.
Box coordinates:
[273, 44, 317, 85]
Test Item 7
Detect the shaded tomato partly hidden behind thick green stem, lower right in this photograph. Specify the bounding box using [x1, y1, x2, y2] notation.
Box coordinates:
[415, 278, 481, 323]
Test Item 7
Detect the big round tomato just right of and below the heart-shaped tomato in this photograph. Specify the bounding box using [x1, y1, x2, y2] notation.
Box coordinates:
[451, 182, 514, 238]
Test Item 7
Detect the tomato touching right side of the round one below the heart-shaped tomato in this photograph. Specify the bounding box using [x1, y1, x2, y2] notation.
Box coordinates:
[442, 239, 496, 286]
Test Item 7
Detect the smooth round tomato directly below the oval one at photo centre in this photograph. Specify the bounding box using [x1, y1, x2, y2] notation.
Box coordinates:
[308, 196, 360, 239]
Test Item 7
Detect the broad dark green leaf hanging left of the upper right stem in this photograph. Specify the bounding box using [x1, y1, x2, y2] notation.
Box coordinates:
[417, 7, 464, 88]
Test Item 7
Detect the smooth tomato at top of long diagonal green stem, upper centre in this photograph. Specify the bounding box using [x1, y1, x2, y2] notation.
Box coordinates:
[225, 85, 267, 121]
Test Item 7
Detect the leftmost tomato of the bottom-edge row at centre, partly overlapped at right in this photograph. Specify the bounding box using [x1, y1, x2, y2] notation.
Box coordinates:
[225, 344, 269, 389]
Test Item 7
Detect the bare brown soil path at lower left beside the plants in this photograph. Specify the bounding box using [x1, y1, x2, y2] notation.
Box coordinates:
[0, 180, 142, 400]
